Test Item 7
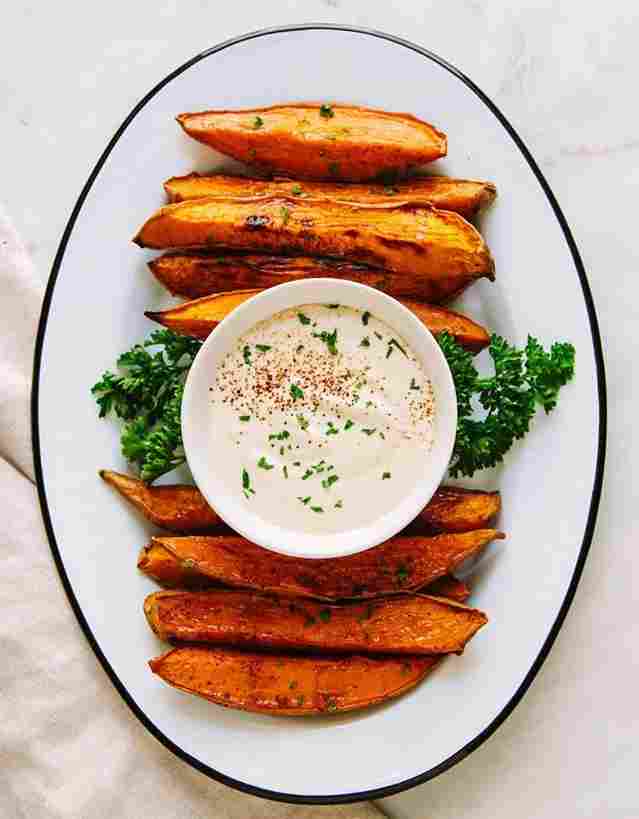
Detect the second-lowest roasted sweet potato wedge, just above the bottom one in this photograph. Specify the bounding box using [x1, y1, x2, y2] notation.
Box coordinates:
[144, 589, 488, 654]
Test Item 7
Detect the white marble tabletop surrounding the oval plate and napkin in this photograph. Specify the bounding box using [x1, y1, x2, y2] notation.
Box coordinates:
[0, 0, 639, 819]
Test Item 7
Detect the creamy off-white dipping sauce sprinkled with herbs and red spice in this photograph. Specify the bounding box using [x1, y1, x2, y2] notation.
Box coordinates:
[210, 304, 434, 533]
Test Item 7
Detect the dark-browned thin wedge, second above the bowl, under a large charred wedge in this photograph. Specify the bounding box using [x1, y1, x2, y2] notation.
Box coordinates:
[149, 252, 480, 304]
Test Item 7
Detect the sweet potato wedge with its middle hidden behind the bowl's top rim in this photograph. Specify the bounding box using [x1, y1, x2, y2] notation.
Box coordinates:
[144, 290, 490, 353]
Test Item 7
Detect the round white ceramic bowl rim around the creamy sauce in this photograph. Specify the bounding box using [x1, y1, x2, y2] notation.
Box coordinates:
[182, 279, 457, 558]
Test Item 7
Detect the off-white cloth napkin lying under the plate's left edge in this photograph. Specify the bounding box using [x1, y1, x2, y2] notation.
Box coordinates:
[0, 209, 381, 819]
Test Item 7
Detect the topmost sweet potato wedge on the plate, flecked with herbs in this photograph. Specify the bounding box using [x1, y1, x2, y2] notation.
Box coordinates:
[177, 102, 446, 181]
